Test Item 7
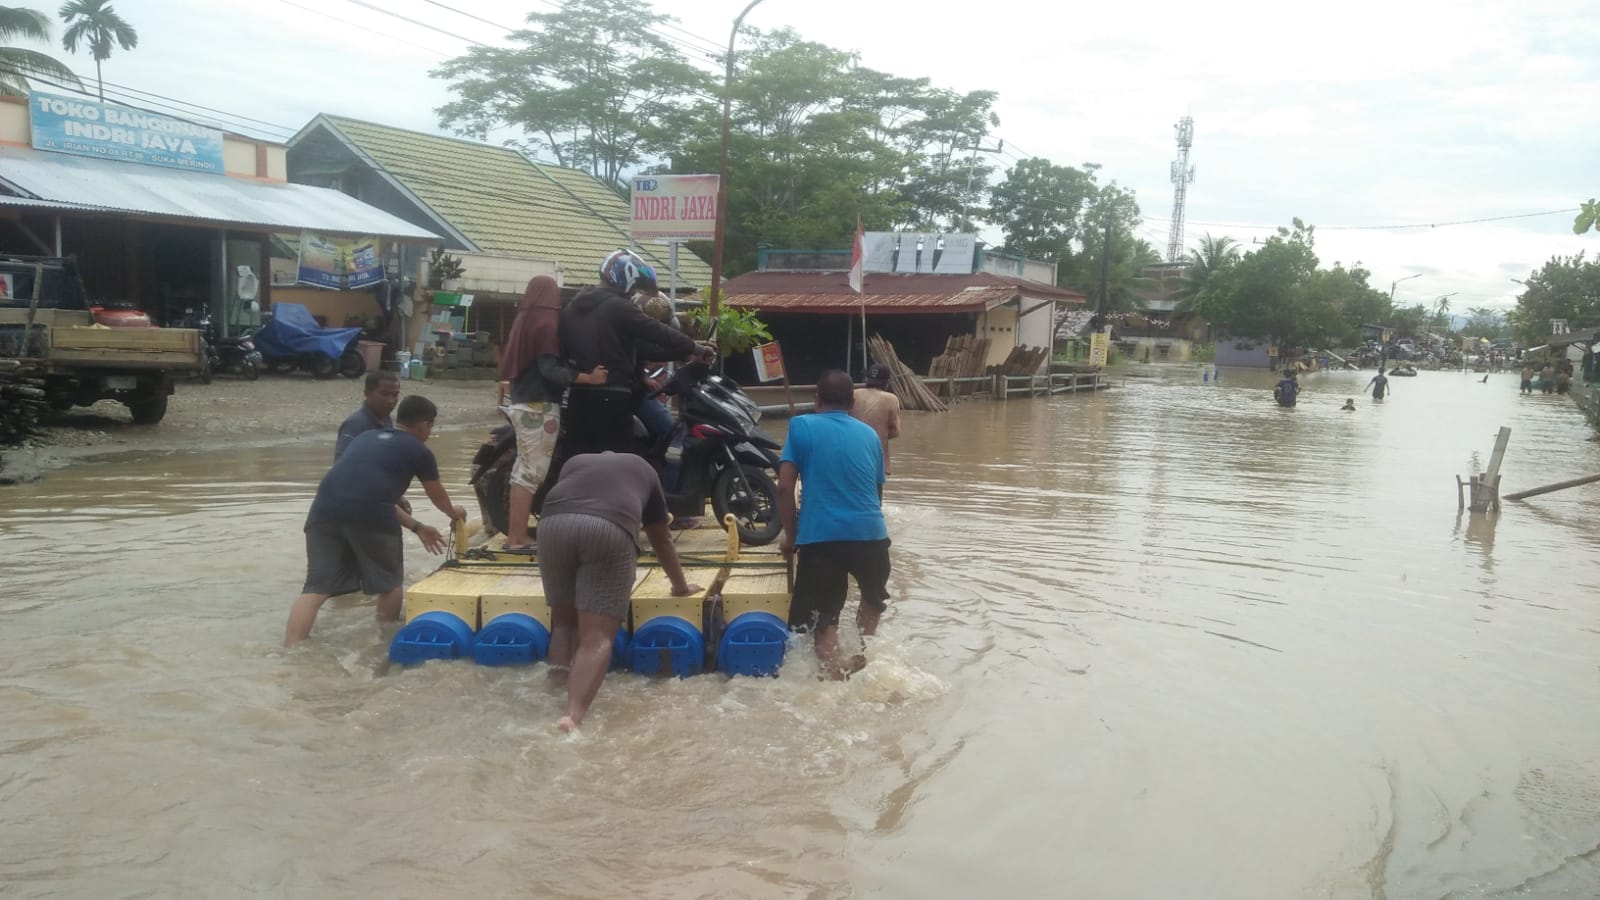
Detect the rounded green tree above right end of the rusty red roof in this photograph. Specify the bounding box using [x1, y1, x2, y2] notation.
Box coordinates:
[989, 157, 1099, 259]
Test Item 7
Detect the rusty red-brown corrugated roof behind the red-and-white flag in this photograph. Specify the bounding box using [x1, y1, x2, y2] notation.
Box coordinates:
[725, 265, 1085, 315]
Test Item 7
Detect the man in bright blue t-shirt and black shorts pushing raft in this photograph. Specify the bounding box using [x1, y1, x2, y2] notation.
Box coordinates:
[778, 368, 890, 677]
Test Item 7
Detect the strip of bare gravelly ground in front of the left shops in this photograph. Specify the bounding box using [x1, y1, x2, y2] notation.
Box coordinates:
[0, 375, 499, 479]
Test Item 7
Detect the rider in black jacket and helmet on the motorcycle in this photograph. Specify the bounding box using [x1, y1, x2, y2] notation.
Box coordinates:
[533, 250, 713, 512]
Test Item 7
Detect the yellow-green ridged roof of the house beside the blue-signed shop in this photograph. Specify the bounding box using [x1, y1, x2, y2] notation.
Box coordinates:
[312, 114, 710, 287]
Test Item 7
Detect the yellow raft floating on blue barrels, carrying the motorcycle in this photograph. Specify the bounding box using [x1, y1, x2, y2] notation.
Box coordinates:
[390, 517, 790, 674]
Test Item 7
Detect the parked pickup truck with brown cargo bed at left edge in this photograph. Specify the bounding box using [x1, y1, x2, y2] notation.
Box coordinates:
[0, 256, 205, 424]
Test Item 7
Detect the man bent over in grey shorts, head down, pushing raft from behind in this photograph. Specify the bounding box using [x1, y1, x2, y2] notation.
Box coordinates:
[539, 453, 704, 732]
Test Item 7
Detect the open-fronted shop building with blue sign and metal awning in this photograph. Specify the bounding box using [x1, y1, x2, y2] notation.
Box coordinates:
[0, 91, 442, 333]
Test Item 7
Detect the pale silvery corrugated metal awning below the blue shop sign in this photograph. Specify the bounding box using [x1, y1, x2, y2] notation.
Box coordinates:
[0, 146, 438, 242]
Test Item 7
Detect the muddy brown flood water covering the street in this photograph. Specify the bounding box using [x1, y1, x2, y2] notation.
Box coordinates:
[0, 368, 1600, 900]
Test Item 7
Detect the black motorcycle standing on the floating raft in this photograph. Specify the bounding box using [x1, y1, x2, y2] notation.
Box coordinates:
[470, 362, 782, 546]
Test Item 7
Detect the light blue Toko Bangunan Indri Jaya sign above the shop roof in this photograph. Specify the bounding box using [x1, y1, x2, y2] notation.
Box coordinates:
[27, 91, 224, 175]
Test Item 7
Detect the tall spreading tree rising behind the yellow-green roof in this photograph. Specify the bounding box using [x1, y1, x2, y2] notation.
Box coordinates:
[432, 0, 712, 191]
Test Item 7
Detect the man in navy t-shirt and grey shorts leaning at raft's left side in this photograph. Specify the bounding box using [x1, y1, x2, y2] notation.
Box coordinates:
[283, 396, 467, 647]
